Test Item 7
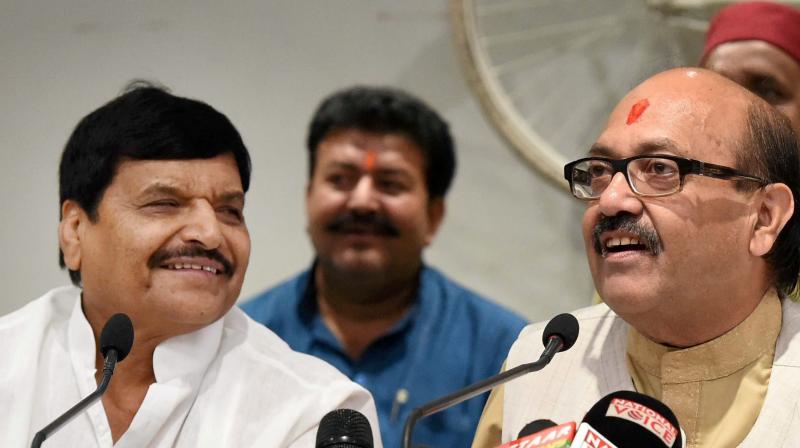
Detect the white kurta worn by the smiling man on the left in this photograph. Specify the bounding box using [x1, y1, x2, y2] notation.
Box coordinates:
[0, 287, 382, 448]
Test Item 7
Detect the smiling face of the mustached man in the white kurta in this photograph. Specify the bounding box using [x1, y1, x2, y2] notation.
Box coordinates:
[59, 154, 250, 336]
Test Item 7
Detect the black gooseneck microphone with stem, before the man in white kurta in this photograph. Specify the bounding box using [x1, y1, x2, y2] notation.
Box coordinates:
[31, 313, 133, 448]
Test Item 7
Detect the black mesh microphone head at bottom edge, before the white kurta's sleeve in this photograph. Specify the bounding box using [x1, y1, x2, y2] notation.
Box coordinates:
[314, 409, 373, 448]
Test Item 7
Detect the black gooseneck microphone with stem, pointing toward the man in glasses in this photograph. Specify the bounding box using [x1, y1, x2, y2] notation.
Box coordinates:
[403, 313, 579, 448]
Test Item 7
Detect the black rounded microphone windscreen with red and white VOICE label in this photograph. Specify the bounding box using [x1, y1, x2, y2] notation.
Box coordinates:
[583, 390, 683, 448]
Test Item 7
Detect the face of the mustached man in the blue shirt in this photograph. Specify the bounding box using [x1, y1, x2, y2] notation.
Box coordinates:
[306, 129, 444, 288]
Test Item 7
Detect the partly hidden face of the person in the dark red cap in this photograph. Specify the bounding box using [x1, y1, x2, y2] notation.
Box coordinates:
[703, 40, 800, 132]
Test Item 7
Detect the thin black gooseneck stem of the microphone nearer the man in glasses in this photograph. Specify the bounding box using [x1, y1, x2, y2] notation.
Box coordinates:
[403, 336, 564, 448]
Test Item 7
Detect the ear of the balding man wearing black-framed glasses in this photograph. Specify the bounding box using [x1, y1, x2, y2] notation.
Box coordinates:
[750, 184, 794, 257]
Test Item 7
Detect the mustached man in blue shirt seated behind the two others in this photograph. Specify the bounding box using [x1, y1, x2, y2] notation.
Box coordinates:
[242, 87, 525, 448]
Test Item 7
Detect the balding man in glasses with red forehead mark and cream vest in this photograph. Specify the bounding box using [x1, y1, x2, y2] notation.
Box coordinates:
[473, 69, 800, 448]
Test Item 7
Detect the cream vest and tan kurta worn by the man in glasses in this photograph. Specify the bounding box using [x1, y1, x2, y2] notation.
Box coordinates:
[473, 293, 800, 448]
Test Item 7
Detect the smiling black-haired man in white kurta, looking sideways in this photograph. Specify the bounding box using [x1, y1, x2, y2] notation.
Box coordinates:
[0, 84, 381, 448]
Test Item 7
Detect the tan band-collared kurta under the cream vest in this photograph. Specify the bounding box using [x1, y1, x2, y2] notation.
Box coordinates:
[472, 290, 780, 448]
